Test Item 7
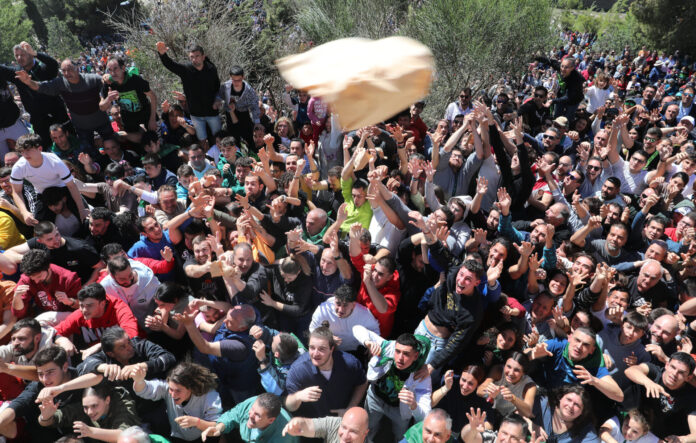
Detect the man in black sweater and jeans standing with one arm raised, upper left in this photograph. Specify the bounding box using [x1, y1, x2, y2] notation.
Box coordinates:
[157, 42, 222, 146]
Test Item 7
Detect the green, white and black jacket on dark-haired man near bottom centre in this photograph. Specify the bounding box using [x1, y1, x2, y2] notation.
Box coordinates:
[374, 335, 430, 406]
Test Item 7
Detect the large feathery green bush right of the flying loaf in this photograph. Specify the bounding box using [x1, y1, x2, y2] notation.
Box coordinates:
[402, 0, 554, 125]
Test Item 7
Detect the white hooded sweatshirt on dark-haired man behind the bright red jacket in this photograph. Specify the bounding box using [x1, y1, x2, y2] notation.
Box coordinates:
[101, 259, 160, 329]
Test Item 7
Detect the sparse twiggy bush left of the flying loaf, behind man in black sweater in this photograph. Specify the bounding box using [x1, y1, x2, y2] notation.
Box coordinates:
[106, 0, 284, 108]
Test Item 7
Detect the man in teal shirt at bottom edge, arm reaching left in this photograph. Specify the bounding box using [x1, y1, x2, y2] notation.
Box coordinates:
[201, 392, 300, 443]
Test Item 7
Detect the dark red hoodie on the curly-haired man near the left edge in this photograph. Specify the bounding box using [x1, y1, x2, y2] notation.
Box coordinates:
[12, 264, 82, 319]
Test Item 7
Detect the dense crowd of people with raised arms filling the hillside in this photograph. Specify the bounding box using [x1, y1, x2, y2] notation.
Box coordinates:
[0, 32, 696, 443]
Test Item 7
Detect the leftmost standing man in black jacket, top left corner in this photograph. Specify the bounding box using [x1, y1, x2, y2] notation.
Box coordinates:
[0, 42, 69, 143]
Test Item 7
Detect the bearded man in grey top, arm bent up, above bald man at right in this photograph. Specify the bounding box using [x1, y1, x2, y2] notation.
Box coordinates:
[570, 215, 640, 266]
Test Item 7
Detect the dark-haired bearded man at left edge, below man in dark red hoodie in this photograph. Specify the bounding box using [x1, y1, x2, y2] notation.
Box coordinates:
[0, 318, 56, 401]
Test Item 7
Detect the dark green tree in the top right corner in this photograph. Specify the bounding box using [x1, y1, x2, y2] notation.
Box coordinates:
[630, 0, 696, 54]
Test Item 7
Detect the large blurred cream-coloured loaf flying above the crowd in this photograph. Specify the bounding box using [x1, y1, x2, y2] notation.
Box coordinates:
[275, 37, 434, 130]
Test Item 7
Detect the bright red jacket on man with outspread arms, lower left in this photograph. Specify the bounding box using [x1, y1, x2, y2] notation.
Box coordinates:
[56, 295, 145, 347]
